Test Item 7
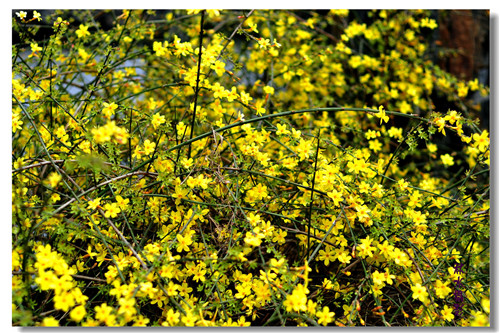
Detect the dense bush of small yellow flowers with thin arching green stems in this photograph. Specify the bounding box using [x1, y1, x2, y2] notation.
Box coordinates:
[12, 10, 490, 326]
